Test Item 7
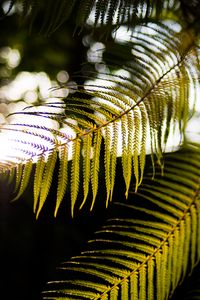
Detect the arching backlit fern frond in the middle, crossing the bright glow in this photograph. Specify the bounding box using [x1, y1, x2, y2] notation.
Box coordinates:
[0, 23, 199, 215]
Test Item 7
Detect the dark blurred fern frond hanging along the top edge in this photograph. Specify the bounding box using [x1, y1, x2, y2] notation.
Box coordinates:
[2, 0, 177, 34]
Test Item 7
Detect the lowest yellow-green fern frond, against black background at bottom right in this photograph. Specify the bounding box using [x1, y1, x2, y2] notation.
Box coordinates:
[43, 144, 200, 300]
